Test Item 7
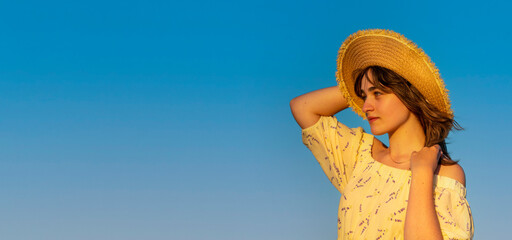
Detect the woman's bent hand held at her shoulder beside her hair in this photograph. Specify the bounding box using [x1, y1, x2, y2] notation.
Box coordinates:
[411, 144, 443, 173]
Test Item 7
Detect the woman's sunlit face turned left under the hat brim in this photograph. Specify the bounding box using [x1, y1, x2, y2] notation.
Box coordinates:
[361, 69, 413, 135]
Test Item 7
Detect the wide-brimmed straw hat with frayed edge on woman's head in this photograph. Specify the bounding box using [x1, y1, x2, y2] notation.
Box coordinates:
[336, 29, 453, 119]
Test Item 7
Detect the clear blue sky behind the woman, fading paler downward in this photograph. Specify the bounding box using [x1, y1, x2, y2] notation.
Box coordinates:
[0, 0, 512, 240]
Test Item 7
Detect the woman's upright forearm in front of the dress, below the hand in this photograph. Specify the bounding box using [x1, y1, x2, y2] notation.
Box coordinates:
[404, 170, 443, 240]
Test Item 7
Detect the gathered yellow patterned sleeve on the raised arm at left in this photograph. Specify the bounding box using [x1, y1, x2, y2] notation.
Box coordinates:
[302, 116, 363, 192]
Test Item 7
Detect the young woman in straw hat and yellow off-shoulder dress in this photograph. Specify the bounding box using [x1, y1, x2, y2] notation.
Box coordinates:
[290, 29, 474, 239]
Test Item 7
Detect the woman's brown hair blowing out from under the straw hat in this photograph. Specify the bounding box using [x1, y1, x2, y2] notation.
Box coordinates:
[354, 66, 463, 165]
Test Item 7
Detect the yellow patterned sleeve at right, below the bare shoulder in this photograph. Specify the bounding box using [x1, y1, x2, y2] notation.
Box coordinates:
[434, 179, 474, 239]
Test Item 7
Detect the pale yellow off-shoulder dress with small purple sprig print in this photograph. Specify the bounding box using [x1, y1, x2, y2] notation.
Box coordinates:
[302, 116, 474, 239]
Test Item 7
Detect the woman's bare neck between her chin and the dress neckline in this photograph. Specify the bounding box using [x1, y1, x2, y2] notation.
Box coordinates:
[388, 114, 425, 166]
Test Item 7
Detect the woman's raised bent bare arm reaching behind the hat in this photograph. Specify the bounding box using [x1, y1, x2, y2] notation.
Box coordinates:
[290, 86, 348, 129]
